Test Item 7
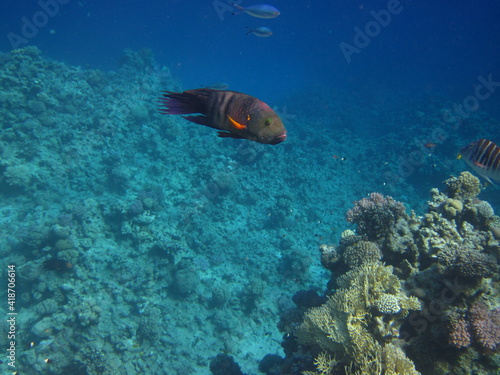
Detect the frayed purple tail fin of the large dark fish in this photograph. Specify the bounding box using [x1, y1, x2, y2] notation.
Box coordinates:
[158, 89, 206, 115]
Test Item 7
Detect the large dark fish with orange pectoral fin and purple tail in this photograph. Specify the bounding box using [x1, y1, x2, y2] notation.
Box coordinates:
[159, 89, 286, 145]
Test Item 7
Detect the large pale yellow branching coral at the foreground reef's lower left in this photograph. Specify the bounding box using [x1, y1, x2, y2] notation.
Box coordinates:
[297, 262, 420, 374]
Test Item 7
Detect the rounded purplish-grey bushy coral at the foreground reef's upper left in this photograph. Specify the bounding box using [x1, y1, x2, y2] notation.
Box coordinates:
[346, 193, 408, 240]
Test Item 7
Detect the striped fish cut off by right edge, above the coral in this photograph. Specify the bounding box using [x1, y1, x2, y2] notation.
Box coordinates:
[460, 139, 500, 183]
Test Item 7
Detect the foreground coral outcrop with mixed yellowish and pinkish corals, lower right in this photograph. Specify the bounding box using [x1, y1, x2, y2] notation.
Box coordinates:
[274, 173, 500, 375]
